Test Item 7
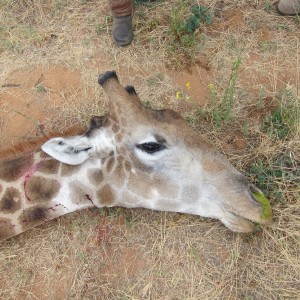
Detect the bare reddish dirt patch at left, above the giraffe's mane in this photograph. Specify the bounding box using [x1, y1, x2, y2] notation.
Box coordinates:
[0, 66, 81, 147]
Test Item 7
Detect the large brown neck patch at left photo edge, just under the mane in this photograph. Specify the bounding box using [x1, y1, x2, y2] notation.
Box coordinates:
[0, 155, 33, 182]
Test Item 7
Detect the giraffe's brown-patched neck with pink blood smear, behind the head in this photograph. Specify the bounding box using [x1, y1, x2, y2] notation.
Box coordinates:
[0, 151, 104, 240]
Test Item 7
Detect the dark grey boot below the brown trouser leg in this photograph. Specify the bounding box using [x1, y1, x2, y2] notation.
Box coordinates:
[112, 15, 133, 46]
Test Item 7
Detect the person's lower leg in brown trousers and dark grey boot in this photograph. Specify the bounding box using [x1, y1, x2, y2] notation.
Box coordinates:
[109, 0, 133, 46]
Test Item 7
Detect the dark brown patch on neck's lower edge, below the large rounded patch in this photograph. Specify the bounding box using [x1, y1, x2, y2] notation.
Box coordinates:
[19, 206, 48, 231]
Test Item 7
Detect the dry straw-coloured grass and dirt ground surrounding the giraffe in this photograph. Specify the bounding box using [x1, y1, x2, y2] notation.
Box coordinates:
[0, 0, 300, 300]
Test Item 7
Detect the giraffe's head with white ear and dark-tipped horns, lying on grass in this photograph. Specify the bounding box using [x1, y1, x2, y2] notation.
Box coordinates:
[42, 72, 272, 232]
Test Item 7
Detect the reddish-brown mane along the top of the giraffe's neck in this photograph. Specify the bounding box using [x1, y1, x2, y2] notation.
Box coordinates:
[0, 125, 85, 160]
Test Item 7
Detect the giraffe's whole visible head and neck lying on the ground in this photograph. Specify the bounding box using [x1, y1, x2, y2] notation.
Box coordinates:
[0, 71, 272, 240]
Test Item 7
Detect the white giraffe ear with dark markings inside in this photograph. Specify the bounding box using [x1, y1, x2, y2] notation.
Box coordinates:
[41, 136, 92, 165]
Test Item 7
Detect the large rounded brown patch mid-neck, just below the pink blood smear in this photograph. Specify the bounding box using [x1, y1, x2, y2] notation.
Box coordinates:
[25, 176, 60, 203]
